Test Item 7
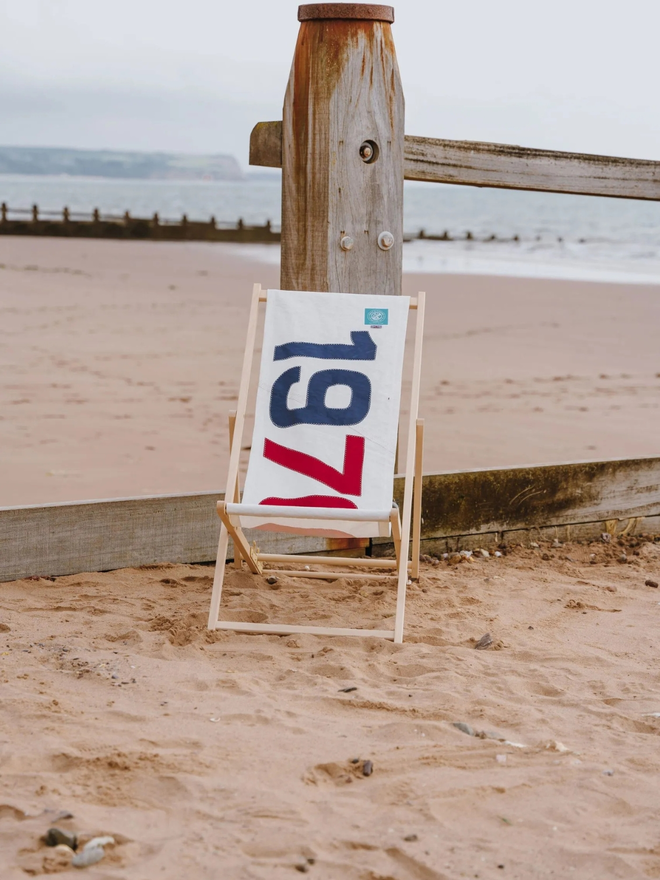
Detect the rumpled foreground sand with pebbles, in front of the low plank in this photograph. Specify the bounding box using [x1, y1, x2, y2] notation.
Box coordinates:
[0, 539, 660, 880]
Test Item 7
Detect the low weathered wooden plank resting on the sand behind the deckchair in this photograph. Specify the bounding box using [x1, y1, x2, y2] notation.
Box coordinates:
[0, 458, 660, 581]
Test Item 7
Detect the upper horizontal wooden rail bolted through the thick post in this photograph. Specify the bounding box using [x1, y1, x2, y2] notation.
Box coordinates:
[250, 122, 660, 201]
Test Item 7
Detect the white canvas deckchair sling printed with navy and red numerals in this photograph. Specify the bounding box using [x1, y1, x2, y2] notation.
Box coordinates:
[238, 290, 410, 537]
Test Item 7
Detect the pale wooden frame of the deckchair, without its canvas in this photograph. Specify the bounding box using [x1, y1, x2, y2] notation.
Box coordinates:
[208, 284, 425, 644]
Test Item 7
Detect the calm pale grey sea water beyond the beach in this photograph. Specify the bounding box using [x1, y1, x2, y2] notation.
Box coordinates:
[0, 175, 660, 283]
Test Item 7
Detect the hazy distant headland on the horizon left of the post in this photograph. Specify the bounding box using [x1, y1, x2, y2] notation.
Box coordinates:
[0, 147, 246, 180]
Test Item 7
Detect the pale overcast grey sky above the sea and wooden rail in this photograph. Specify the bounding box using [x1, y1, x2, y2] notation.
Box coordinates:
[0, 0, 660, 166]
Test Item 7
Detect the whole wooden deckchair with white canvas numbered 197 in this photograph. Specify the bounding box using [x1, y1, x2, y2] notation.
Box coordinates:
[208, 284, 425, 643]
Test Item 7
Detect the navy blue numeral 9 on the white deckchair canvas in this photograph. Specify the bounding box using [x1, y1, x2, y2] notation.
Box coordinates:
[270, 368, 371, 428]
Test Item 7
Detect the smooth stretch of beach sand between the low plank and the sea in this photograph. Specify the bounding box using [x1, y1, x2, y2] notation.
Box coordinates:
[0, 237, 660, 506]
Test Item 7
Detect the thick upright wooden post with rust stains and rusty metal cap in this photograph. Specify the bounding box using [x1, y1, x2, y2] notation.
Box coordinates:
[280, 3, 404, 294]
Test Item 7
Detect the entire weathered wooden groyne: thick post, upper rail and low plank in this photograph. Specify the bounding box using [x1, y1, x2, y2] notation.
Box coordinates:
[0, 3, 660, 581]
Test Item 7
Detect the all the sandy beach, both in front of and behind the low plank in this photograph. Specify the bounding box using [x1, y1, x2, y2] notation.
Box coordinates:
[0, 238, 660, 880]
